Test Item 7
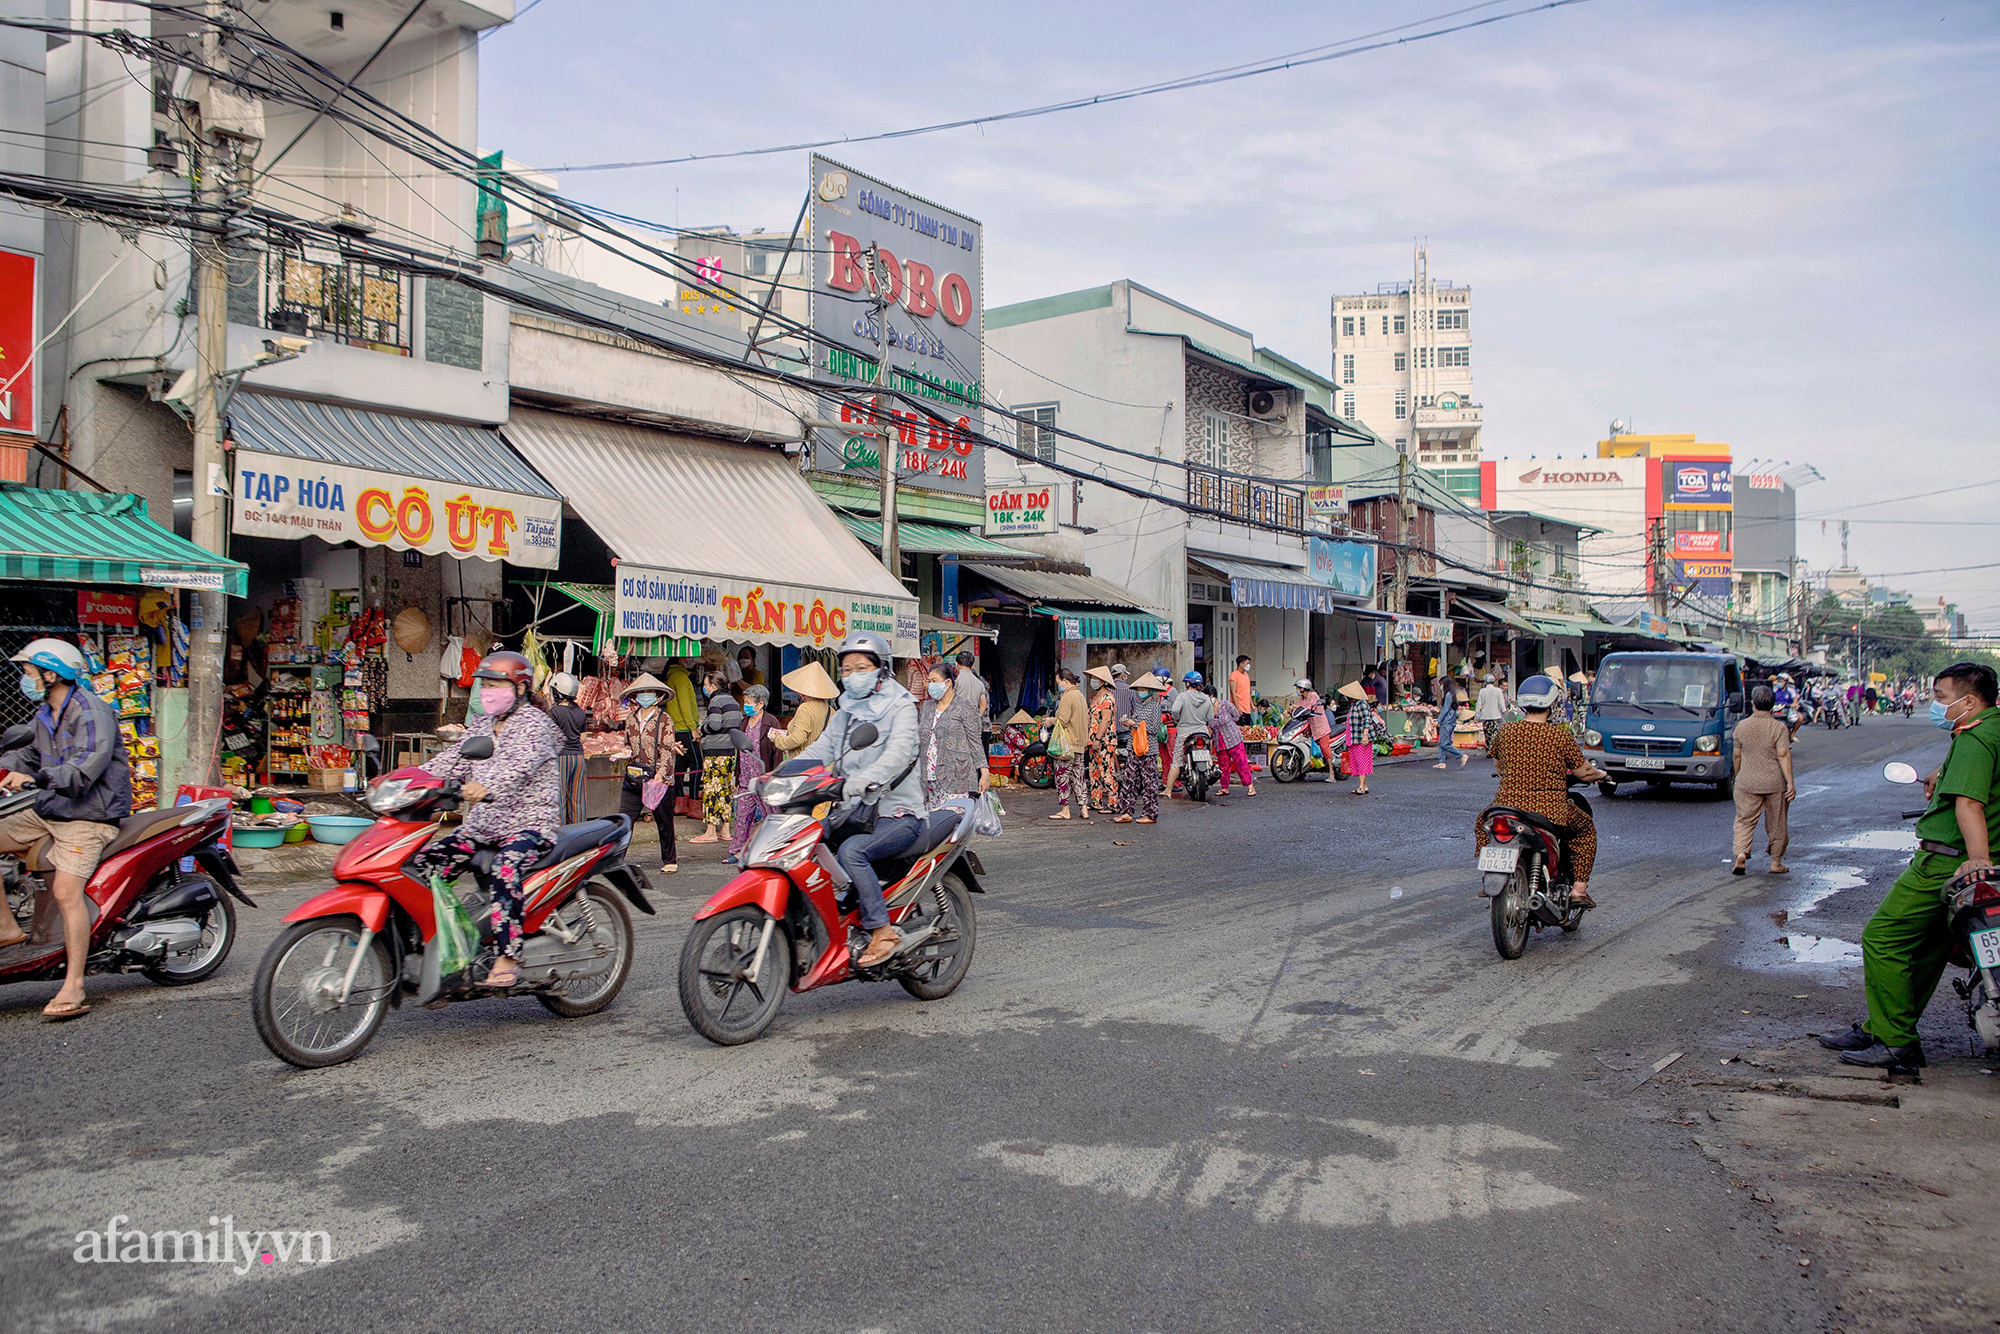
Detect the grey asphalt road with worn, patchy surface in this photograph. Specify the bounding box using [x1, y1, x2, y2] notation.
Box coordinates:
[0, 718, 1962, 1334]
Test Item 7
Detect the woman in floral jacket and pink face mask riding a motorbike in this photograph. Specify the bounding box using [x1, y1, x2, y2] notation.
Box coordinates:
[406, 648, 562, 990]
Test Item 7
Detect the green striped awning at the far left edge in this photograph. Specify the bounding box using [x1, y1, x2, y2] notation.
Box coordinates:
[0, 482, 250, 598]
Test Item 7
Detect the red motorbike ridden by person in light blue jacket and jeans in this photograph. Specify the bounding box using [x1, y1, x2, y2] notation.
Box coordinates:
[680, 722, 986, 1046]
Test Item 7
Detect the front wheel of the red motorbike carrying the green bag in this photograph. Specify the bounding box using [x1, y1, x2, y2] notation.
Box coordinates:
[250, 916, 394, 1070]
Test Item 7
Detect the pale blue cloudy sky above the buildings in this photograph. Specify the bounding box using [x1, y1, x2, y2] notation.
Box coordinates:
[480, 0, 2000, 630]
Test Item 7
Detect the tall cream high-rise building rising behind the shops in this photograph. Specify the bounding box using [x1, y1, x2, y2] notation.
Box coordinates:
[1332, 246, 1480, 470]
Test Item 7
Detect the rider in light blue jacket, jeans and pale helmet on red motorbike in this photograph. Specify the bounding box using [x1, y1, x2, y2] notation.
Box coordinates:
[796, 630, 926, 968]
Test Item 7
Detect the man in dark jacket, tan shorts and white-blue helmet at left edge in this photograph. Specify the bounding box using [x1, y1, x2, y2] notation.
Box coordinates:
[0, 640, 132, 1020]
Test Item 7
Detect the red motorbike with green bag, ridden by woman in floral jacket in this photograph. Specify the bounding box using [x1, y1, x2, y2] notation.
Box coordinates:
[250, 736, 652, 1070]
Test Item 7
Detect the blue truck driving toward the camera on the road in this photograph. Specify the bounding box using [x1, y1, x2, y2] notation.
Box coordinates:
[1584, 652, 1750, 796]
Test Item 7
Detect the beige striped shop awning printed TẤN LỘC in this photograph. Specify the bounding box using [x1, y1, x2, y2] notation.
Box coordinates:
[500, 408, 918, 656]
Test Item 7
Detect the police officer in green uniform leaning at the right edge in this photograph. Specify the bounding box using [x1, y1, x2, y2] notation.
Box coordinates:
[1820, 662, 2000, 1074]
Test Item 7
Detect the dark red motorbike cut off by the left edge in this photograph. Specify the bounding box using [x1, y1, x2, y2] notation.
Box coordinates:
[0, 724, 256, 986]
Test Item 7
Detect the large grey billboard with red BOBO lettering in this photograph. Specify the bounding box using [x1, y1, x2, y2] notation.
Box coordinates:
[806, 154, 986, 496]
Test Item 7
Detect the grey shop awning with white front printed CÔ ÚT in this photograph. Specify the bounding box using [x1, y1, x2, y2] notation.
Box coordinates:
[230, 392, 562, 570]
